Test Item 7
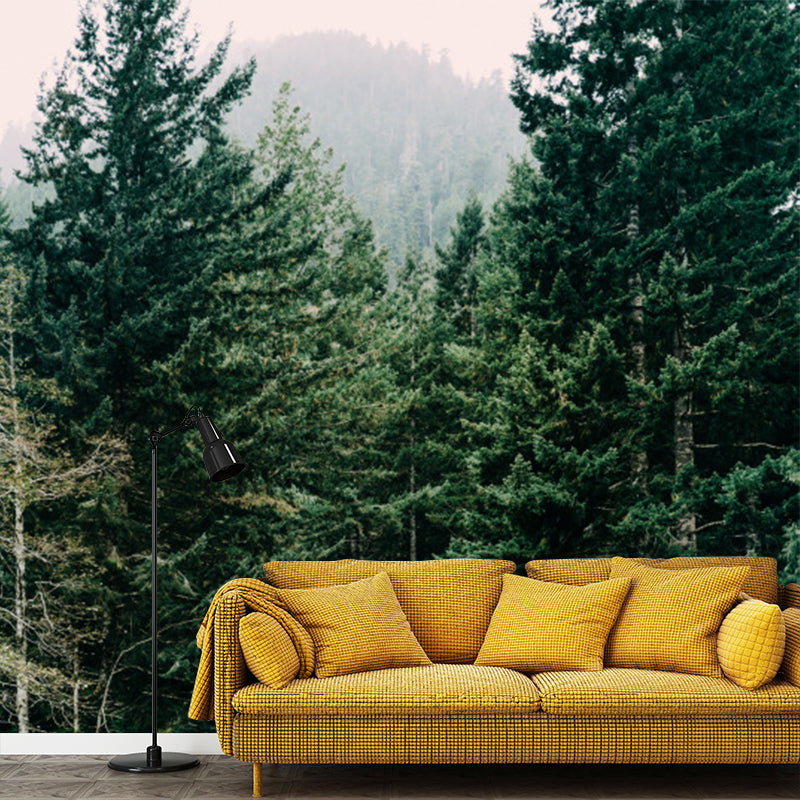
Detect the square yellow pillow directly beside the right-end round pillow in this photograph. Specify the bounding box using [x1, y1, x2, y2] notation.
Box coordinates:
[605, 557, 749, 678]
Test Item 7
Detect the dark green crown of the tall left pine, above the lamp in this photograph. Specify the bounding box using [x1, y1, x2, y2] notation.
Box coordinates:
[16, 0, 255, 427]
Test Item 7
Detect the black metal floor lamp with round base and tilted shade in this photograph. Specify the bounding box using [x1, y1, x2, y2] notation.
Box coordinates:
[108, 408, 244, 772]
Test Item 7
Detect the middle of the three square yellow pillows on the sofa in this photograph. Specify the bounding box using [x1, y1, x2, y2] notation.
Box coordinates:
[475, 575, 630, 672]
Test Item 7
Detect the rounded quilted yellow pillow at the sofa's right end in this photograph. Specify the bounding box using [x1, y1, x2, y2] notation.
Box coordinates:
[717, 597, 786, 689]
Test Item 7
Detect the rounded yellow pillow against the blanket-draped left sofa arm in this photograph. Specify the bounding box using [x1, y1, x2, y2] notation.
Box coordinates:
[239, 611, 300, 689]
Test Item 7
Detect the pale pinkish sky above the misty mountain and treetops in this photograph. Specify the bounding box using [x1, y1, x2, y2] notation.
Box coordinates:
[0, 0, 542, 136]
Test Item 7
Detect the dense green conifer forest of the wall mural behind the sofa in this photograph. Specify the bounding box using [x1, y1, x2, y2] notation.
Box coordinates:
[0, 0, 800, 732]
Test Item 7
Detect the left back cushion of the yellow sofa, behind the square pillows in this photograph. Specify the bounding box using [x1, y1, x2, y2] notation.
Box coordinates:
[264, 558, 515, 664]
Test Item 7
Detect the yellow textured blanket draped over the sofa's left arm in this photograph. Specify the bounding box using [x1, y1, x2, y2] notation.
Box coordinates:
[189, 578, 314, 720]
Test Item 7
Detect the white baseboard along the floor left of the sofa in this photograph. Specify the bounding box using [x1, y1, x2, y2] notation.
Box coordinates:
[0, 733, 222, 756]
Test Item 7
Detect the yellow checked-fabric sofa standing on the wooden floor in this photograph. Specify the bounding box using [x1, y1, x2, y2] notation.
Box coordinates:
[189, 557, 800, 797]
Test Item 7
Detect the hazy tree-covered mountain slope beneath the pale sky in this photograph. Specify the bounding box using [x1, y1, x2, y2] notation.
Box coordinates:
[231, 32, 524, 258]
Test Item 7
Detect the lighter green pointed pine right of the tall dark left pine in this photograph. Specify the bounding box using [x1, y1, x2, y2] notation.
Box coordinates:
[165, 85, 388, 576]
